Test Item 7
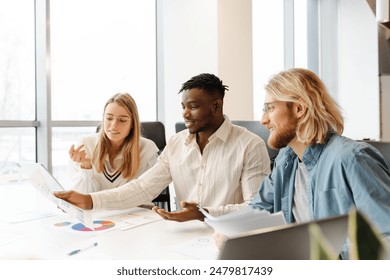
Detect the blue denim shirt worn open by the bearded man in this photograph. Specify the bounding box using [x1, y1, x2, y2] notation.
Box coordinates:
[250, 134, 390, 241]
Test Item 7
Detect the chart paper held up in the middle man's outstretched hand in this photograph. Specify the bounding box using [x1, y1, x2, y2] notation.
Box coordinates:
[20, 163, 95, 230]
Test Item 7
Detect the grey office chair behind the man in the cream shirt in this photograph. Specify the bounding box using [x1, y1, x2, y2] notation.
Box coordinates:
[175, 121, 279, 170]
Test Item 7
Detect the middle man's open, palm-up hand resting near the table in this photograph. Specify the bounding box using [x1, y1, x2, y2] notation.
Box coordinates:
[153, 201, 204, 222]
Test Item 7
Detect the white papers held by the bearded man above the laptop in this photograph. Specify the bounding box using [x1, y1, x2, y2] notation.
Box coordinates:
[199, 206, 286, 236]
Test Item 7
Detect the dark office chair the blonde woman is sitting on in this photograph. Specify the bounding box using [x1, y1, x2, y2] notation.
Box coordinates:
[141, 121, 171, 211]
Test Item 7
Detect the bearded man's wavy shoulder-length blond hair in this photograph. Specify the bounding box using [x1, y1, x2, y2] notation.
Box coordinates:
[265, 68, 344, 144]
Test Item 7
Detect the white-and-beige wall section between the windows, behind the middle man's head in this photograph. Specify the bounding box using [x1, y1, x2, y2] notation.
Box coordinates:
[159, 0, 253, 137]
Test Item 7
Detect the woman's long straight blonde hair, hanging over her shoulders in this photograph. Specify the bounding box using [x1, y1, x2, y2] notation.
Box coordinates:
[92, 93, 141, 179]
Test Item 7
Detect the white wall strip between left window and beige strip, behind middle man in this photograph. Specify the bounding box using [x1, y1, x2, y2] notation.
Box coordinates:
[161, 0, 218, 137]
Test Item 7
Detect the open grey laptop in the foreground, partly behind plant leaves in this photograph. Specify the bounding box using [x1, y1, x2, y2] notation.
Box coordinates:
[218, 215, 348, 260]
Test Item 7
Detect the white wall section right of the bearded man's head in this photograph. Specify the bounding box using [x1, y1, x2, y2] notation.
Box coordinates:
[338, 0, 380, 140]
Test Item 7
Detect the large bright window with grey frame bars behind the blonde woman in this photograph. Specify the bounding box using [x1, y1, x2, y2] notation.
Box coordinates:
[0, 0, 157, 187]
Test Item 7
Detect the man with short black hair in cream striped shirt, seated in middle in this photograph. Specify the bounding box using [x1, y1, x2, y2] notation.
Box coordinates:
[56, 73, 270, 222]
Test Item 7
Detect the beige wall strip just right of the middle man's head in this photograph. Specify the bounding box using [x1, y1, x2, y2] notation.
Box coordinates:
[218, 0, 253, 120]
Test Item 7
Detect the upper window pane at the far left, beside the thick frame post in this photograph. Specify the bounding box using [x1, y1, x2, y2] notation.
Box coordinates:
[0, 0, 35, 121]
